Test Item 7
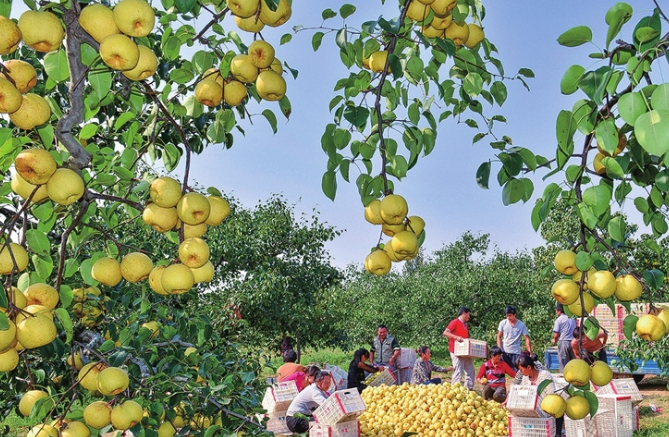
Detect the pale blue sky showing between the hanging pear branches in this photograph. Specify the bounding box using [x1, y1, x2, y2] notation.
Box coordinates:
[185, 0, 653, 267]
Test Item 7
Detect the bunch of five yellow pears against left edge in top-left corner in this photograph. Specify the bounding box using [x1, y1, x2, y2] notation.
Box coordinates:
[0, 11, 58, 129]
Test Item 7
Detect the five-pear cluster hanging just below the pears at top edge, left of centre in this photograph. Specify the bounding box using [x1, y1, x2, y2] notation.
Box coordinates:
[195, 40, 286, 108]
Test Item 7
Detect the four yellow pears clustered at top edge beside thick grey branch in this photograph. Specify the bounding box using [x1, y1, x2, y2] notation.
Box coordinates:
[79, 0, 158, 81]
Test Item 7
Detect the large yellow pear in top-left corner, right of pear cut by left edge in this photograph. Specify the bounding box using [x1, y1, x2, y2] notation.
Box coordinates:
[19, 11, 65, 52]
